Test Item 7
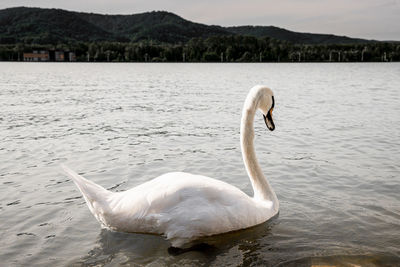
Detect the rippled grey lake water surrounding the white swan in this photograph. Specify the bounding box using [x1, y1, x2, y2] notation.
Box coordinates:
[0, 63, 400, 266]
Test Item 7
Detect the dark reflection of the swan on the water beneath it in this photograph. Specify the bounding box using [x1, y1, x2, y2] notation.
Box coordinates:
[71, 219, 278, 266]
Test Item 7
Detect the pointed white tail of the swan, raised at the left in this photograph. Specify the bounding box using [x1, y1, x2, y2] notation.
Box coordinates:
[61, 165, 114, 227]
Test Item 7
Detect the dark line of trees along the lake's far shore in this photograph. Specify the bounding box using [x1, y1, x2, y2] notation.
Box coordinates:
[0, 35, 400, 62]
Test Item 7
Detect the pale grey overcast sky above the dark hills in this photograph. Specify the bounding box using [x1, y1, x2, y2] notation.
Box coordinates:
[0, 0, 400, 40]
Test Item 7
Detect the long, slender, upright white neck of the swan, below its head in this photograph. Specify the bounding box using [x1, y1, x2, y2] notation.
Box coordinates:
[240, 98, 278, 203]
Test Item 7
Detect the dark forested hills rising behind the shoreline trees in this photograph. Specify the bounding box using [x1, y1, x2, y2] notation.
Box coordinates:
[0, 7, 371, 44]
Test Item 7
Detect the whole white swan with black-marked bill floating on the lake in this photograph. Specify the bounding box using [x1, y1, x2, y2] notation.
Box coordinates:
[62, 85, 279, 248]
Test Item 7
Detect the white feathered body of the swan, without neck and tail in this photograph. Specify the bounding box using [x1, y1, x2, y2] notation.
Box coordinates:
[108, 173, 274, 246]
